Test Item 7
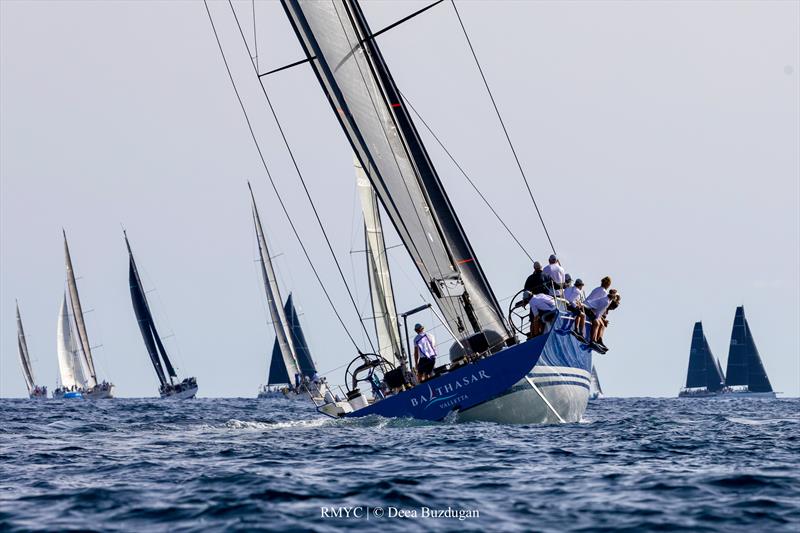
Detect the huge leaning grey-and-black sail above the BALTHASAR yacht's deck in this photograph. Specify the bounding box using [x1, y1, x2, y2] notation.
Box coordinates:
[282, 0, 511, 345]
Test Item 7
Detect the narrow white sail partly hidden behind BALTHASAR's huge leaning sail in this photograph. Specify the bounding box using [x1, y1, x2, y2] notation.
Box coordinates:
[353, 156, 402, 366]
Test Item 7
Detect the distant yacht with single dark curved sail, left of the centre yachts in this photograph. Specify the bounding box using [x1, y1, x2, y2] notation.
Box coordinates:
[123, 231, 197, 399]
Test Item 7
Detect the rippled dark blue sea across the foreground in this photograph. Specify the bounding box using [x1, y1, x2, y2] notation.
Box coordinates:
[0, 398, 800, 532]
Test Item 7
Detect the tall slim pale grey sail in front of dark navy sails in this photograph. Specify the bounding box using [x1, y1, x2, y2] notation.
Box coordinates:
[247, 183, 300, 383]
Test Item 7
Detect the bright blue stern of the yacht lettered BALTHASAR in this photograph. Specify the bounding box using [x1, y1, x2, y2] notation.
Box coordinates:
[346, 333, 551, 420]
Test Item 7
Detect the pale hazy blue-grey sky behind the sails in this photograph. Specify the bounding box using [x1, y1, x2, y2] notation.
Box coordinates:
[0, 0, 800, 397]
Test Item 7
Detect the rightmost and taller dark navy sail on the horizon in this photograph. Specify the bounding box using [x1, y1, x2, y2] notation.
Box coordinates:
[725, 306, 772, 392]
